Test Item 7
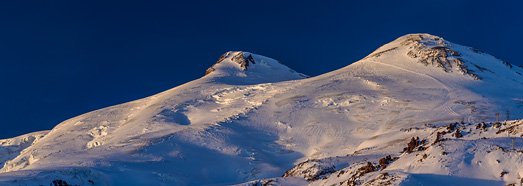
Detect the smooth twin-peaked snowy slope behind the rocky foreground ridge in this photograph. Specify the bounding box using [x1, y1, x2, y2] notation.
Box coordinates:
[0, 34, 523, 185]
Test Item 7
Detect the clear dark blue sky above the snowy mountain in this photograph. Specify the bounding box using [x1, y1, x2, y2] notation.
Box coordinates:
[0, 0, 523, 138]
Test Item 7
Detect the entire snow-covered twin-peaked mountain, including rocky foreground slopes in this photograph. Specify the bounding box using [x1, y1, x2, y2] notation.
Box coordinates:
[0, 34, 523, 185]
